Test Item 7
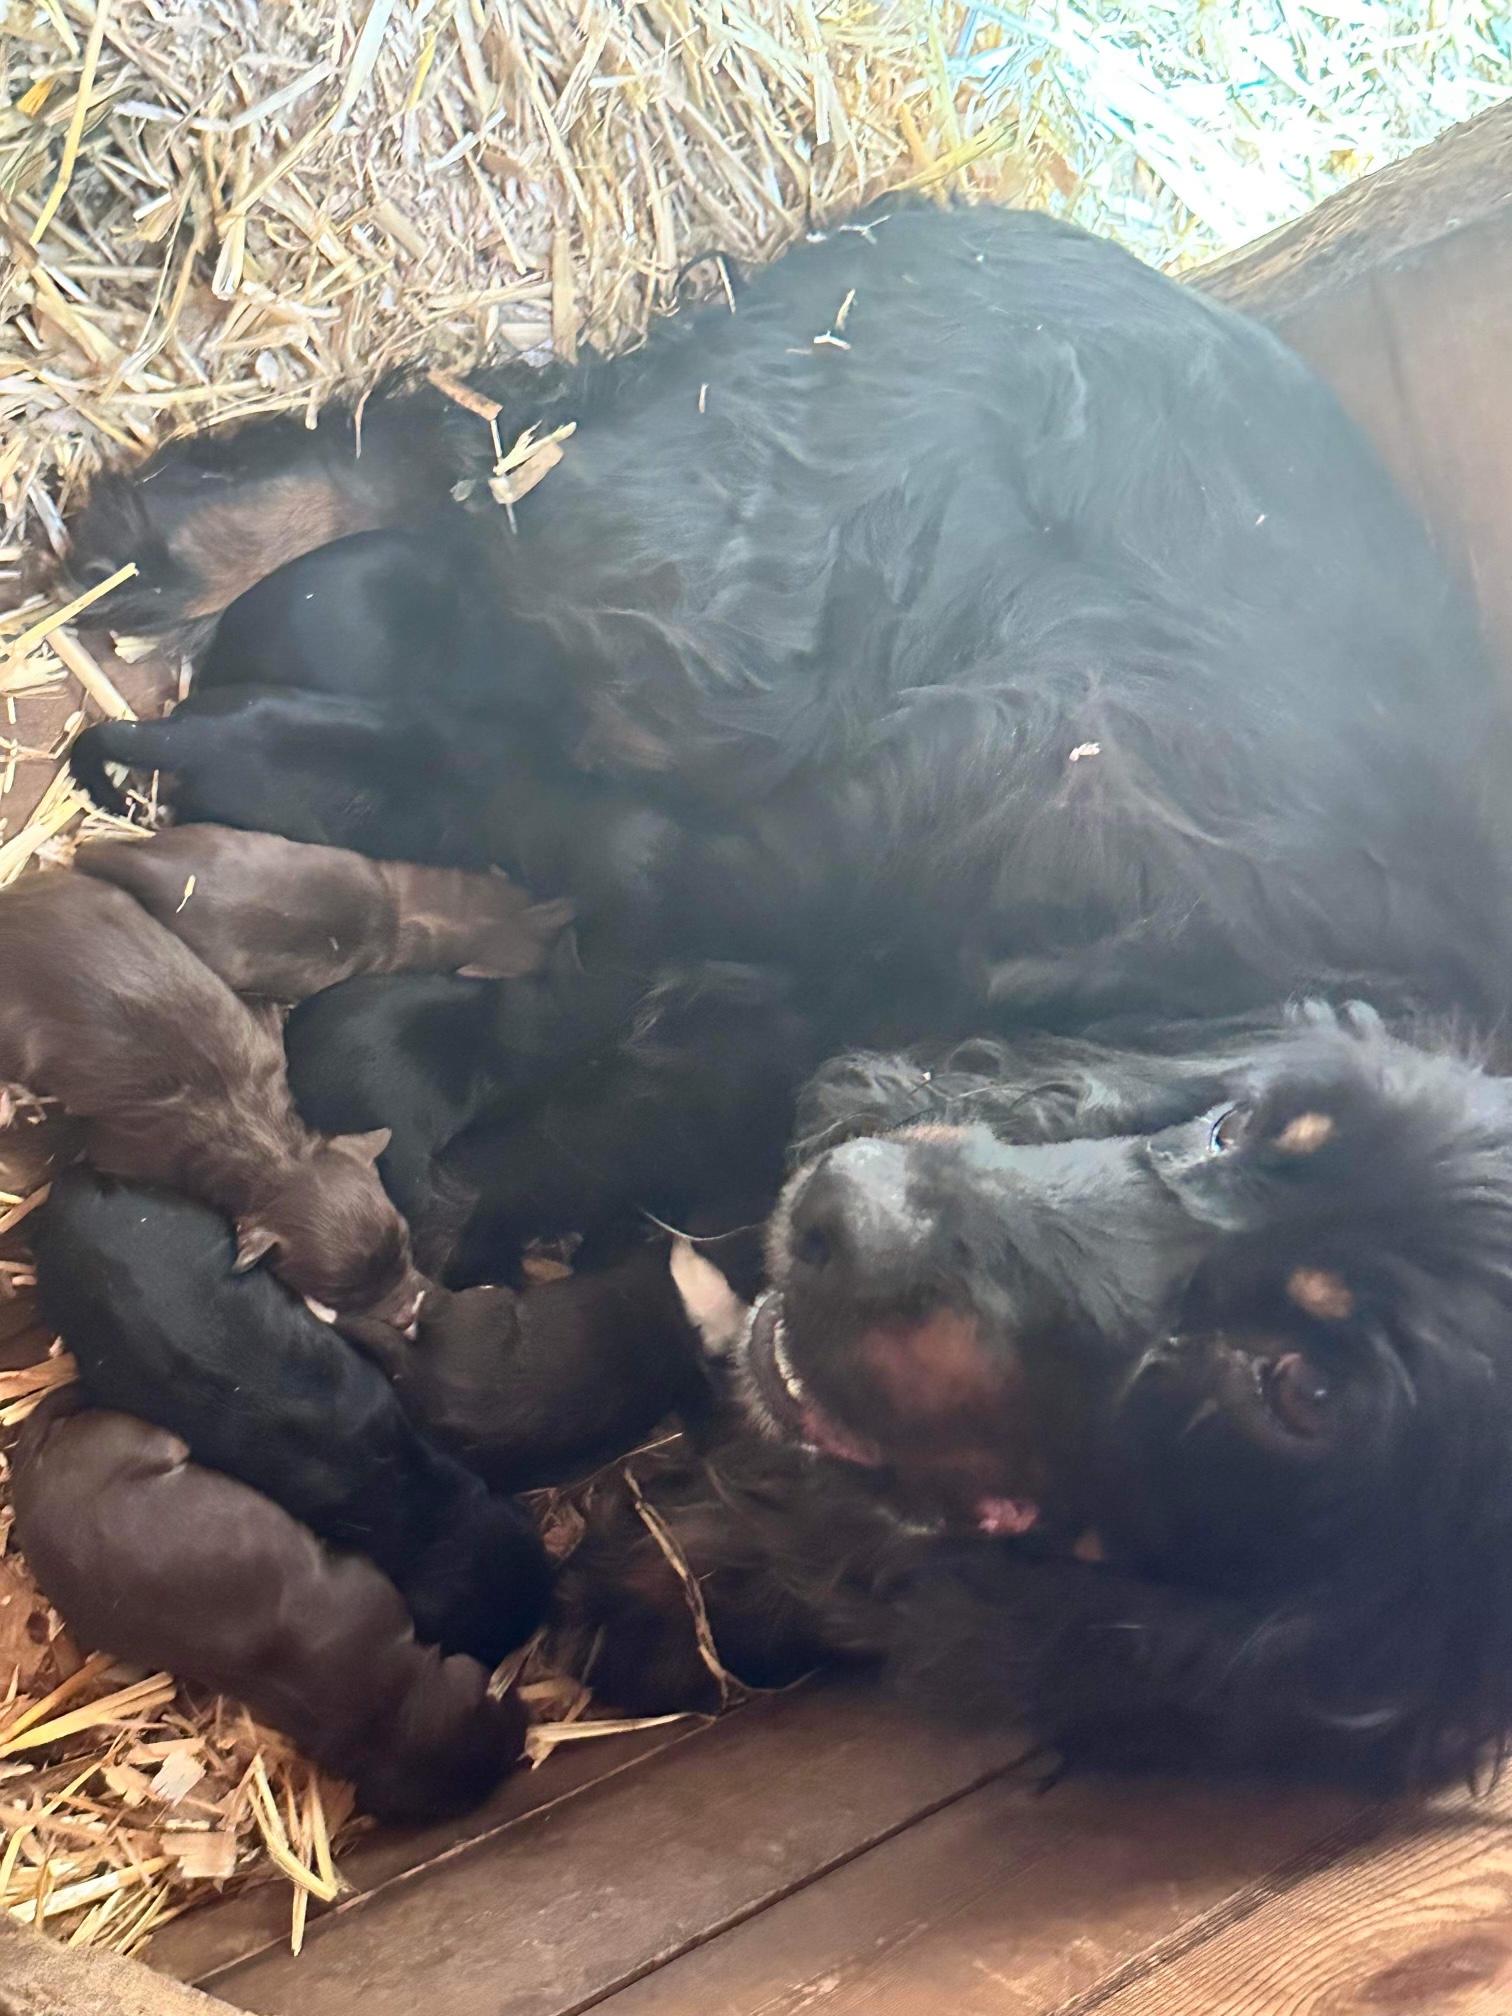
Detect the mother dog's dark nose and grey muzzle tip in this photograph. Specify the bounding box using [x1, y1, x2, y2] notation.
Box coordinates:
[790, 1141, 933, 1296]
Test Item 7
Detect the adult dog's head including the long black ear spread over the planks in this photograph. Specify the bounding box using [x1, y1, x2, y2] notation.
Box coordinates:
[558, 1014, 1512, 1784]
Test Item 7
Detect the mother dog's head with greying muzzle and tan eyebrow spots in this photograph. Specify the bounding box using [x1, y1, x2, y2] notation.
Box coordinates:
[744, 1014, 1512, 1772]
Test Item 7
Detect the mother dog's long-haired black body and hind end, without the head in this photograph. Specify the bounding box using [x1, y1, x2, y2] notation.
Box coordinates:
[62, 202, 1508, 1024]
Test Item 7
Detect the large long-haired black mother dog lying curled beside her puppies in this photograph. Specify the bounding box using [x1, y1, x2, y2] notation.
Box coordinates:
[59, 206, 1512, 1780]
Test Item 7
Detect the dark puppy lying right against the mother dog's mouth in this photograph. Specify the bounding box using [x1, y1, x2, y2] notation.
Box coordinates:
[343, 1244, 712, 1492]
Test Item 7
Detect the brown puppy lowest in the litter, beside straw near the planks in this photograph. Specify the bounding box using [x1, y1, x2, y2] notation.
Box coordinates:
[12, 1395, 524, 1820]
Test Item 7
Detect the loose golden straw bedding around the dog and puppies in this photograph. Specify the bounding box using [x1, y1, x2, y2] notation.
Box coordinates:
[0, 0, 1512, 1951]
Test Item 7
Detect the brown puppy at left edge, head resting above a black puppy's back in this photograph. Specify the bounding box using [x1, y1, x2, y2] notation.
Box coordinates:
[0, 875, 421, 1329]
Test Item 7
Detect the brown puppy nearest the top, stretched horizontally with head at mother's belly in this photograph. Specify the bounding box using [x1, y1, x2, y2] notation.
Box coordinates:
[75, 827, 573, 1002]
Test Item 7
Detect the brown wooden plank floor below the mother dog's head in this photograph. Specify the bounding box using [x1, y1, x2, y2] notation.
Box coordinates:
[149, 1685, 1512, 2016]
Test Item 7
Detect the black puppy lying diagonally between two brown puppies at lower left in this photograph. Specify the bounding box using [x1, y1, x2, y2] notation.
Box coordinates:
[34, 1169, 550, 1665]
